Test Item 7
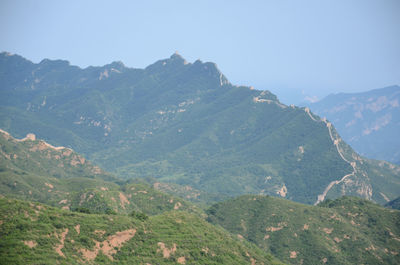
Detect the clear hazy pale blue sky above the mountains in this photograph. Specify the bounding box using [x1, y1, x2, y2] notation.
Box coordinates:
[0, 0, 400, 103]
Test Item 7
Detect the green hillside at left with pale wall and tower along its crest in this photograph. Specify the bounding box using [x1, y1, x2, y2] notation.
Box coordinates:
[0, 131, 201, 215]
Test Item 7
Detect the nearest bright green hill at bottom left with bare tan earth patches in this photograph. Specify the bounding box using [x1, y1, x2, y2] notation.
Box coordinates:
[0, 197, 278, 265]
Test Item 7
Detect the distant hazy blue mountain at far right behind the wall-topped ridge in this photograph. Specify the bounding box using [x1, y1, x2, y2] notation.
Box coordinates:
[307, 86, 400, 164]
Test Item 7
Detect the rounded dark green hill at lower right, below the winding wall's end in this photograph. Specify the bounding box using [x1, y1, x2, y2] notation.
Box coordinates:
[207, 195, 400, 264]
